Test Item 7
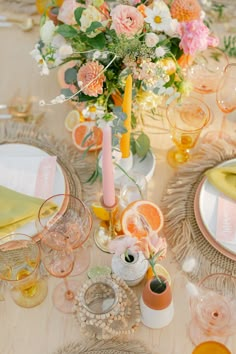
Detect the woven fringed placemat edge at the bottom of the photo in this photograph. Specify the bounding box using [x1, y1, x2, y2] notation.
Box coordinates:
[53, 339, 153, 354]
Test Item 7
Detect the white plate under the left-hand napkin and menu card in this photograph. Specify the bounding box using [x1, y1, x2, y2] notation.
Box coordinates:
[0, 144, 69, 236]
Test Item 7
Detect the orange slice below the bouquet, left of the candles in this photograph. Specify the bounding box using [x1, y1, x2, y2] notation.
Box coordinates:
[72, 122, 102, 151]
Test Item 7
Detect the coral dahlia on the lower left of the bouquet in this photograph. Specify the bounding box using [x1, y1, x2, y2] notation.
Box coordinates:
[77, 61, 106, 97]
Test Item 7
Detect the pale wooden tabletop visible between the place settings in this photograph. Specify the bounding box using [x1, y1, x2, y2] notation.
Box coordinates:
[0, 15, 236, 354]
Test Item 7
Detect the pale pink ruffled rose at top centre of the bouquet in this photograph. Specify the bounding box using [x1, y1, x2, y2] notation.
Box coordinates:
[111, 5, 144, 37]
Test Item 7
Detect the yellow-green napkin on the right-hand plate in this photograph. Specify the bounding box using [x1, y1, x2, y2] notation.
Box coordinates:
[205, 165, 236, 200]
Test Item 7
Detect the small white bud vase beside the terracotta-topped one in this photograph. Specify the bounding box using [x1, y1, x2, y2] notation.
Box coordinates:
[111, 252, 148, 286]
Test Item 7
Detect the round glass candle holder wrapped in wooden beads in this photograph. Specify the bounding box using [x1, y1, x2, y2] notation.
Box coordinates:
[74, 274, 140, 339]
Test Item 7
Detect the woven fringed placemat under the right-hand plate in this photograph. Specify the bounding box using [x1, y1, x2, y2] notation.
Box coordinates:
[161, 140, 236, 281]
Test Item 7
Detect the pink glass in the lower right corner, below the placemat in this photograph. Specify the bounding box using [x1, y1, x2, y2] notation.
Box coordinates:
[189, 273, 236, 345]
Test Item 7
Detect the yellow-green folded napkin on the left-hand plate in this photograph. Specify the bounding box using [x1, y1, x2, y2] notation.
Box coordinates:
[0, 186, 57, 236]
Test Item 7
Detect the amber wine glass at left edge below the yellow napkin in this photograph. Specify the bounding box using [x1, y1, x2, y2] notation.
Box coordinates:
[0, 233, 48, 308]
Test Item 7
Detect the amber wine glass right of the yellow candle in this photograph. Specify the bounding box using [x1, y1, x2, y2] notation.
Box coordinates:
[167, 97, 210, 168]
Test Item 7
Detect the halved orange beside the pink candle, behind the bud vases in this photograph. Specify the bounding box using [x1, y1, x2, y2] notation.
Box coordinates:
[121, 200, 164, 238]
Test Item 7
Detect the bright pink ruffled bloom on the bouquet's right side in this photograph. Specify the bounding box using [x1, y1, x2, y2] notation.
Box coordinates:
[179, 20, 218, 55]
